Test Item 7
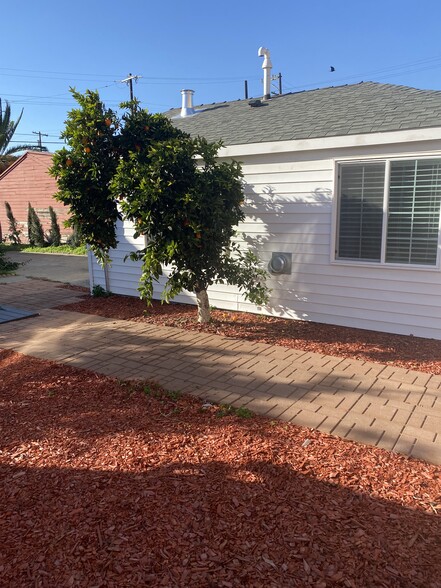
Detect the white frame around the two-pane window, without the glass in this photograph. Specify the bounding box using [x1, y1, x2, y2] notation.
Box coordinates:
[330, 152, 441, 271]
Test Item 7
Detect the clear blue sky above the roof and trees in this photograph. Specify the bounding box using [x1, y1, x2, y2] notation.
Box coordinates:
[4, 0, 441, 151]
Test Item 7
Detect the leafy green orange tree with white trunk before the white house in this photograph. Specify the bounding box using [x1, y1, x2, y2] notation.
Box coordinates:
[52, 93, 269, 322]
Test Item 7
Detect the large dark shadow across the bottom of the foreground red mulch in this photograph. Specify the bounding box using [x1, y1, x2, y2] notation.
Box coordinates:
[0, 460, 441, 588]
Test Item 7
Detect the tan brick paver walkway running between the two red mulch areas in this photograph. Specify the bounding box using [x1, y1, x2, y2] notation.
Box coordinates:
[0, 280, 441, 464]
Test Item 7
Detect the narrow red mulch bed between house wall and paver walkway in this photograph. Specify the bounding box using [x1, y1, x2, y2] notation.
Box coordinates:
[59, 295, 441, 374]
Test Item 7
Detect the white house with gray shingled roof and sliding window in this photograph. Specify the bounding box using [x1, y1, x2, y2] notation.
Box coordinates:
[89, 82, 441, 339]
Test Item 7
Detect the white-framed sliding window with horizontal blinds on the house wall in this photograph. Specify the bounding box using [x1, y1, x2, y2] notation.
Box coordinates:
[336, 159, 441, 266]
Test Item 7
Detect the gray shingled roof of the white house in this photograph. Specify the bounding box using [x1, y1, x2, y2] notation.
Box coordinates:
[166, 82, 441, 145]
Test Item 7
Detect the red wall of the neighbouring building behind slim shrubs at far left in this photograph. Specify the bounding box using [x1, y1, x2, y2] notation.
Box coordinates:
[0, 151, 71, 243]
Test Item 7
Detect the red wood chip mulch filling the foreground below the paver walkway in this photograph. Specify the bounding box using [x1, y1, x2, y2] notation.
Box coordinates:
[0, 351, 441, 588]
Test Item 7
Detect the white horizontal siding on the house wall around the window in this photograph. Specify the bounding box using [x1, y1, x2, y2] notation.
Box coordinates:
[88, 140, 441, 339]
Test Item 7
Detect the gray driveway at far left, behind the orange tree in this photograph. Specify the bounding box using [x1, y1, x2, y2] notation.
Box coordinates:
[0, 251, 89, 287]
